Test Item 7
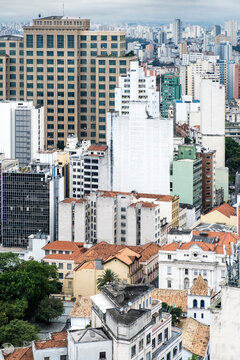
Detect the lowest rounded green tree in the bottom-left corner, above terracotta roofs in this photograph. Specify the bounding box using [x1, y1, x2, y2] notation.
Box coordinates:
[0, 319, 38, 346]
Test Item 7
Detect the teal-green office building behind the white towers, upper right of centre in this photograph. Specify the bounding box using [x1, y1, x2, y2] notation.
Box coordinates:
[161, 74, 181, 118]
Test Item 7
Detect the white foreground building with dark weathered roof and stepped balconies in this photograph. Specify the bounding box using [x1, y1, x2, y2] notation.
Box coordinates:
[91, 284, 182, 360]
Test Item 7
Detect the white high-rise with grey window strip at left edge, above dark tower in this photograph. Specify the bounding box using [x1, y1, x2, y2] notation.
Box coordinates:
[0, 101, 44, 167]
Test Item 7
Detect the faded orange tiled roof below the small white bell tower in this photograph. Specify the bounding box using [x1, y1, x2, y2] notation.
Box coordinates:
[180, 317, 210, 358]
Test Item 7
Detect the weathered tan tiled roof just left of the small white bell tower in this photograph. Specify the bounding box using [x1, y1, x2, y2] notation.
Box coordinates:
[152, 289, 187, 312]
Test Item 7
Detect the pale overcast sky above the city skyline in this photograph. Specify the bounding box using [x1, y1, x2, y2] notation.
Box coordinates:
[0, 0, 240, 24]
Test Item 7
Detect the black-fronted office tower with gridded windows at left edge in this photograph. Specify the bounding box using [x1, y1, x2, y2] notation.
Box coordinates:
[2, 170, 52, 247]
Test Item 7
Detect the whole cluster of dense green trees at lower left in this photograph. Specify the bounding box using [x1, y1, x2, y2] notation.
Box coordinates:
[0, 253, 63, 346]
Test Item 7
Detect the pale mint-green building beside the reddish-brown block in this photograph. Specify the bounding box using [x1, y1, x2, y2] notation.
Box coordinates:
[170, 145, 202, 220]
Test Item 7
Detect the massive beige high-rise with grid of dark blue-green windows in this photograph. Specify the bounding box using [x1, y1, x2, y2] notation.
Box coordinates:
[0, 16, 135, 148]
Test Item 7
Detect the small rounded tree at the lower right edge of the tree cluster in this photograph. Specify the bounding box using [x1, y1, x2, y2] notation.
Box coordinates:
[36, 297, 64, 323]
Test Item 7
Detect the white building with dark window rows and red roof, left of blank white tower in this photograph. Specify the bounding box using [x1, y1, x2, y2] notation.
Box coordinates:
[69, 141, 109, 199]
